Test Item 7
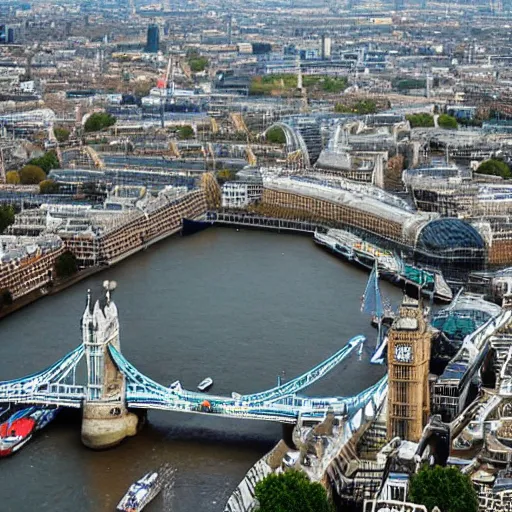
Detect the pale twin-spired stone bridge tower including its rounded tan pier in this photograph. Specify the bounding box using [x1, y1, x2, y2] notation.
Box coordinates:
[82, 281, 138, 449]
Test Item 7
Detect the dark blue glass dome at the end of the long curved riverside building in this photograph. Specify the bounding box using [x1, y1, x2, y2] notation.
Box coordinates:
[416, 218, 485, 257]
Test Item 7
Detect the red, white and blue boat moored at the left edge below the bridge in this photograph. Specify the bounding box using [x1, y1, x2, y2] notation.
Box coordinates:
[0, 407, 59, 457]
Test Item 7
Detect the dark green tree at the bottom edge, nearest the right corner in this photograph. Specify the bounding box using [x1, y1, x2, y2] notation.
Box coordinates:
[408, 466, 478, 512]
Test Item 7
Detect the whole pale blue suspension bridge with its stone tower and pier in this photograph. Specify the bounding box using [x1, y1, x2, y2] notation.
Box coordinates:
[0, 281, 387, 448]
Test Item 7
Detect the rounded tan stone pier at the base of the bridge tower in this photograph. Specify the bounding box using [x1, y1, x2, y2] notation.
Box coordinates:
[82, 401, 139, 450]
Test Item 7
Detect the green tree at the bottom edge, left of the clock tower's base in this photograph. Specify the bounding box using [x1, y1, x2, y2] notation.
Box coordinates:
[255, 470, 334, 512]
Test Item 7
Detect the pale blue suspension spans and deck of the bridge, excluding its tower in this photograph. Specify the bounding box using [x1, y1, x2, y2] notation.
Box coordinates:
[0, 336, 387, 424]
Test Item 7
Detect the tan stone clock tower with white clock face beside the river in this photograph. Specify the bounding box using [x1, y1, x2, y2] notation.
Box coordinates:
[387, 296, 432, 442]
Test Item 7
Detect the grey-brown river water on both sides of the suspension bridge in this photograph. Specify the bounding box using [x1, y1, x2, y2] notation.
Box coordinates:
[0, 228, 401, 512]
